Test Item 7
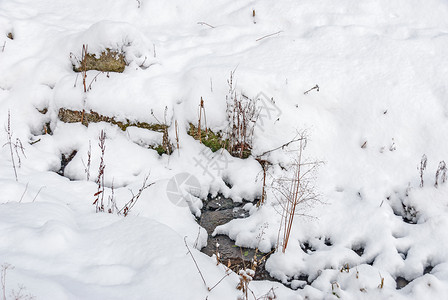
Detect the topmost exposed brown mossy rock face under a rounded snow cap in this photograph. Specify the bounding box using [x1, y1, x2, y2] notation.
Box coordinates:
[73, 48, 126, 73]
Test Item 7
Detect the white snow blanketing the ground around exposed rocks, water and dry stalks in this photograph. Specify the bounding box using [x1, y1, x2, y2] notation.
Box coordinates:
[0, 0, 448, 300]
